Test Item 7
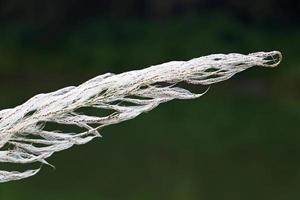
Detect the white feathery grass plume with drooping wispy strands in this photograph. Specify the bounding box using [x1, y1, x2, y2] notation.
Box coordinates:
[0, 51, 281, 183]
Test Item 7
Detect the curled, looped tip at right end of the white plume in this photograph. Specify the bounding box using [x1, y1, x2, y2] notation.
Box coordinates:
[249, 51, 282, 67]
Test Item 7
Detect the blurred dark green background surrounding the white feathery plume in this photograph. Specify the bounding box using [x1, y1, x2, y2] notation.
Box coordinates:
[0, 0, 300, 200]
